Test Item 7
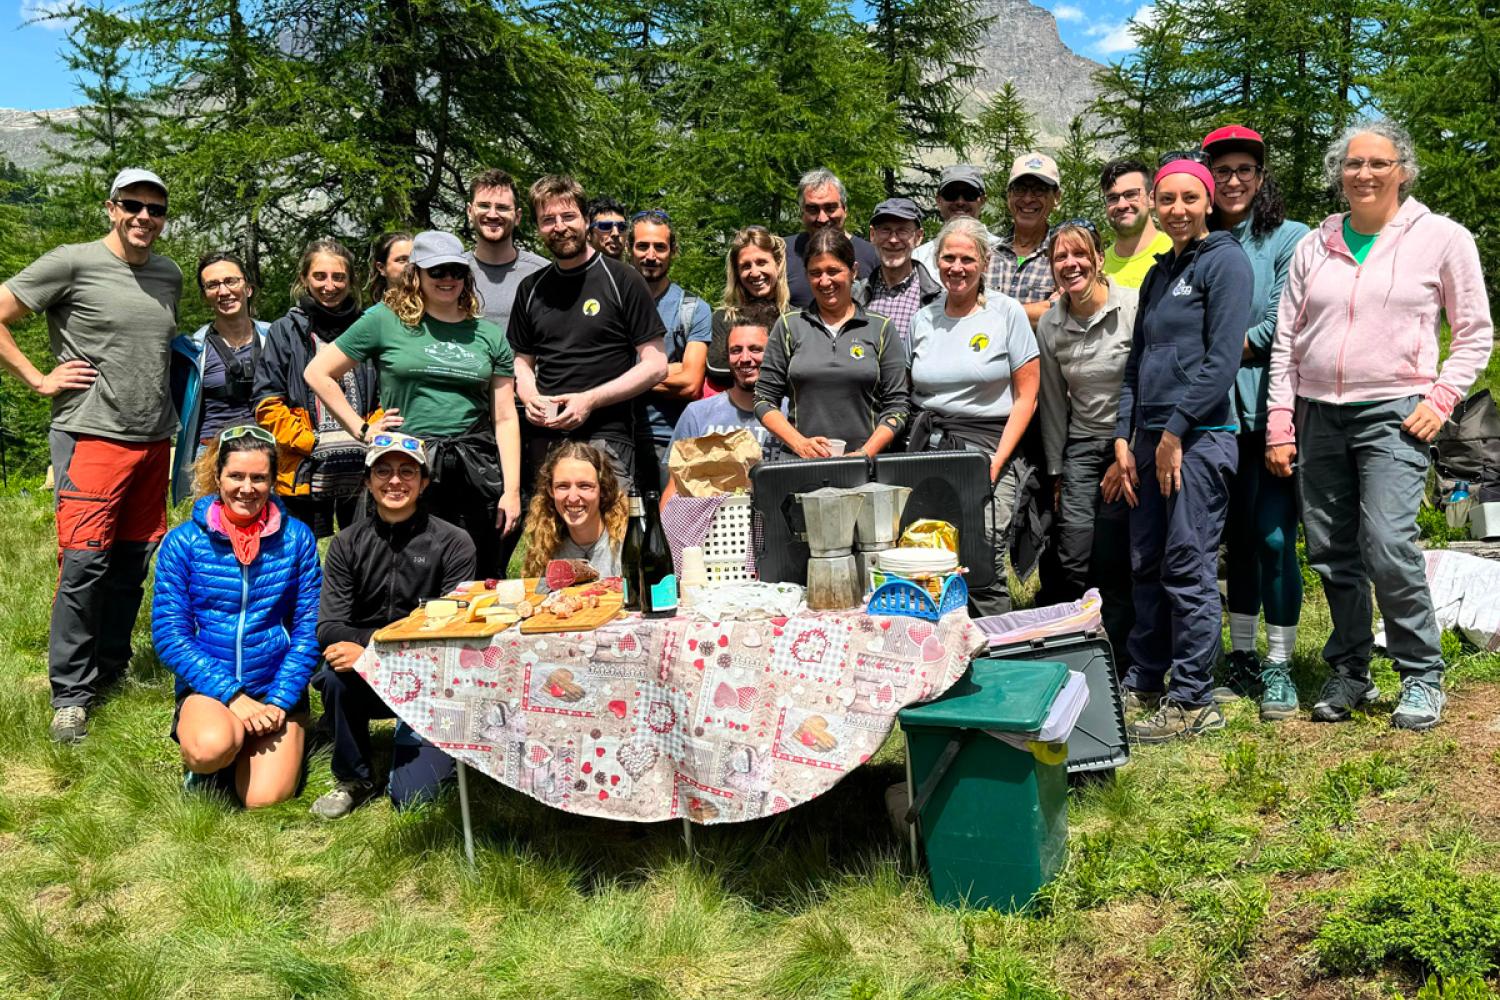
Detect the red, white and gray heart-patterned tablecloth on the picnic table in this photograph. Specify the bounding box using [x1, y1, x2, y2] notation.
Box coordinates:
[357, 612, 984, 823]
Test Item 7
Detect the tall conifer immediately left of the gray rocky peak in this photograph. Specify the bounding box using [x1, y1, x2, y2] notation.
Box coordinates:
[870, 0, 993, 198]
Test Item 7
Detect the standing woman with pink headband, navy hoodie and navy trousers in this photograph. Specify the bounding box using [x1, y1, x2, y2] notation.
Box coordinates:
[1103, 157, 1254, 744]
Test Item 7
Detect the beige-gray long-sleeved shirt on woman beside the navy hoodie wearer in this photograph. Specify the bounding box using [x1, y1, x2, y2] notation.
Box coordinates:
[1037, 280, 1137, 475]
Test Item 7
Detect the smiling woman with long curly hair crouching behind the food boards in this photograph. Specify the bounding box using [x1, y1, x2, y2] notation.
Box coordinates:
[522, 441, 627, 576]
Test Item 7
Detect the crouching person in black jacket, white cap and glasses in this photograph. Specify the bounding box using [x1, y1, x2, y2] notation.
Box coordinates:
[312, 433, 476, 820]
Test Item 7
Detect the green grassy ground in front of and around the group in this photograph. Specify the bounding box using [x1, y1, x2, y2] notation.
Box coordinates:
[0, 496, 1500, 1000]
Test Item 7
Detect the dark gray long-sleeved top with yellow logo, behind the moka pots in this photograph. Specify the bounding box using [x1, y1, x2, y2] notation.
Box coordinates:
[755, 306, 909, 451]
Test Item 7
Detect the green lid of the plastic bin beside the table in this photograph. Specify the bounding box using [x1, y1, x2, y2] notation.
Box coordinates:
[900, 660, 1068, 733]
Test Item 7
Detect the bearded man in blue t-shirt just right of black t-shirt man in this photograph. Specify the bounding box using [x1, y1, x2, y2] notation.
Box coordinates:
[630, 208, 713, 486]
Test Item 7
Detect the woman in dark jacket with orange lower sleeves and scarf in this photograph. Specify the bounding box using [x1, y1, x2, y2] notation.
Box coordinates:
[252, 240, 384, 538]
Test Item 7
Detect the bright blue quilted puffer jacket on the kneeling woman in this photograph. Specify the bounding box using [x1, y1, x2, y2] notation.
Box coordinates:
[152, 496, 323, 711]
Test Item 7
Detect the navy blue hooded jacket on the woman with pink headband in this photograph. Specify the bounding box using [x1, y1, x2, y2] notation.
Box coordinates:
[1115, 232, 1256, 439]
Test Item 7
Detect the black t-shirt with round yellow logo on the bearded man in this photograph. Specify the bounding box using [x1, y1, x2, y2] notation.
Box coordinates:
[507, 253, 666, 441]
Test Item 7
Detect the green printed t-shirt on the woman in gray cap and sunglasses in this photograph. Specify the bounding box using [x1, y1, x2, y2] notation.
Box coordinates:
[333, 303, 516, 438]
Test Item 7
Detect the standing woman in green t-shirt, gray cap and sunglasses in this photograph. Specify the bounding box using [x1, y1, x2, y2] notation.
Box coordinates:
[306, 232, 521, 576]
